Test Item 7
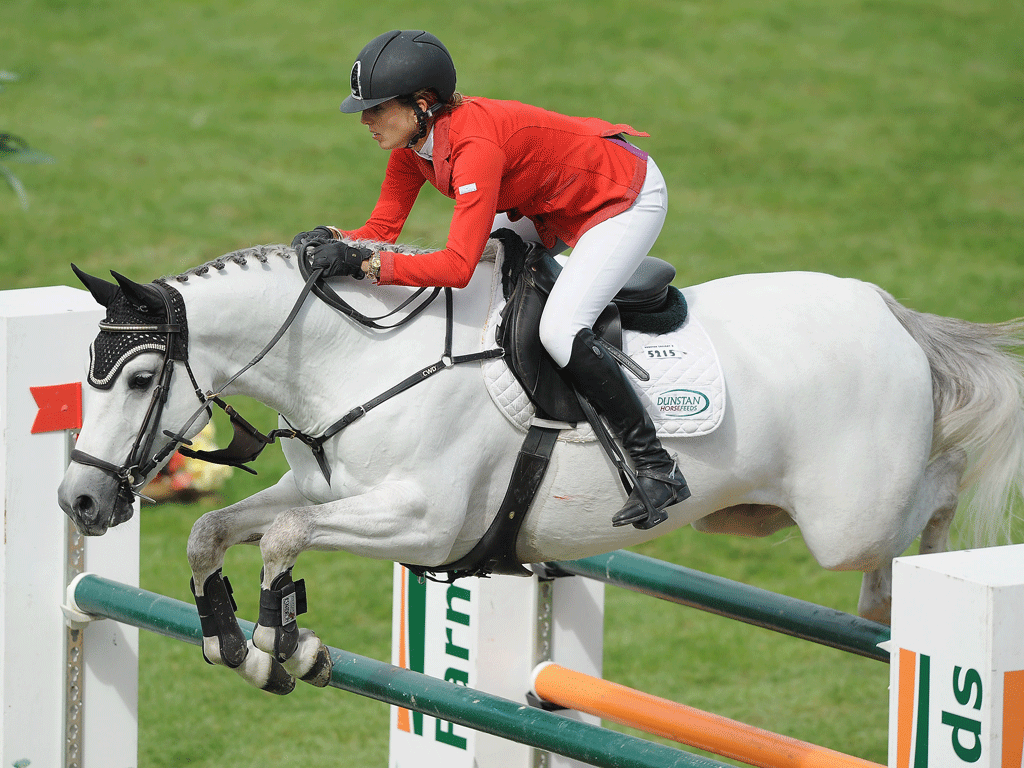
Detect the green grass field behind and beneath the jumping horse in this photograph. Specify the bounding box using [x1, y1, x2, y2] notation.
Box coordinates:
[0, 0, 1024, 768]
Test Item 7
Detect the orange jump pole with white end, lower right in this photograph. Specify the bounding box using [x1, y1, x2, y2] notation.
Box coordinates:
[534, 662, 884, 768]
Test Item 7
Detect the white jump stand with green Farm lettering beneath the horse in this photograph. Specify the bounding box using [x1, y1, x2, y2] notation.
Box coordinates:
[389, 564, 604, 768]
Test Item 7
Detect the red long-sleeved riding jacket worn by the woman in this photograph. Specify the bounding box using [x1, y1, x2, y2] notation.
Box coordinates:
[333, 98, 648, 288]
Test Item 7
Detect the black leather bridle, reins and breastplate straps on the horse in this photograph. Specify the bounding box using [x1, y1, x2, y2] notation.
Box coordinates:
[71, 258, 504, 496]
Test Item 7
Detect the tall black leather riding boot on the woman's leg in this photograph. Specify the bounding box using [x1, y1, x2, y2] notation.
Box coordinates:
[562, 329, 690, 528]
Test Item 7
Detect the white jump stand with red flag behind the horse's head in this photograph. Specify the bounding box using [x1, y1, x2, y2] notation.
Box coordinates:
[0, 286, 139, 768]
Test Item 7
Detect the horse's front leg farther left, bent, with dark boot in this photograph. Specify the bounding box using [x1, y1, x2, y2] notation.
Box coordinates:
[187, 473, 302, 694]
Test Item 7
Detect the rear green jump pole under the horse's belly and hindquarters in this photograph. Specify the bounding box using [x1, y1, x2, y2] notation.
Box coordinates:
[550, 550, 890, 664]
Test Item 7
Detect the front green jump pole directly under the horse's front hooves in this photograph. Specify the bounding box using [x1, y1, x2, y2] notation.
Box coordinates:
[75, 573, 727, 768]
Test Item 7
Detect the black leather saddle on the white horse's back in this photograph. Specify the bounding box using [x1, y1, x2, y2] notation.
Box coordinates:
[490, 229, 686, 424]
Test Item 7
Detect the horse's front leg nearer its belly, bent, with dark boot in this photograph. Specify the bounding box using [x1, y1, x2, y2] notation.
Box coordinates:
[253, 483, 452, 685]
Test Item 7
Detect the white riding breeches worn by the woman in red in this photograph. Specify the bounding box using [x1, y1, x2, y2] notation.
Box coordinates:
[494, 158, 669, 368]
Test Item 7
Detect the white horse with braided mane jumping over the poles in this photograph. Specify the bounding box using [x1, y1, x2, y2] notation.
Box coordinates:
[58, 241, 1024, 691]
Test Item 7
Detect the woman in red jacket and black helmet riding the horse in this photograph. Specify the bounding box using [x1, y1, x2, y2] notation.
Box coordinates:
[292, 30, 689, 526]
